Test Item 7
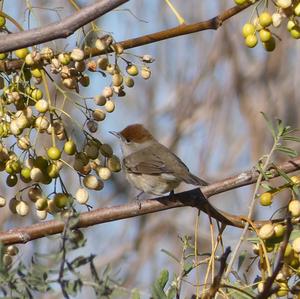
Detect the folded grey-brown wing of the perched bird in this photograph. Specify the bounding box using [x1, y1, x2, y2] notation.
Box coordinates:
[123, 145, 189, 175]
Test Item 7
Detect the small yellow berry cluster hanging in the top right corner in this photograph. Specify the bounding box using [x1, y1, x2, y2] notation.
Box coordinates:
[235, 0, 300, 51]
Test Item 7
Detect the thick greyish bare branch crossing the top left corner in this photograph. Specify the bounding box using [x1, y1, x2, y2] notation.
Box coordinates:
[0, 0, 129, 53]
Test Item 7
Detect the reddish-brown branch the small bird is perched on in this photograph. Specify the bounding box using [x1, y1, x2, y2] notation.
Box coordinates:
[0, 157, 300, 244]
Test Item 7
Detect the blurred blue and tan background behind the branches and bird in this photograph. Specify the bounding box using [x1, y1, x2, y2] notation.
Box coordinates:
[0, 0, 300, 298]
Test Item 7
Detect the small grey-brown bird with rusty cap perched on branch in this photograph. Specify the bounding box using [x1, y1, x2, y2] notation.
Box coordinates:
[110, 124, 208, 199]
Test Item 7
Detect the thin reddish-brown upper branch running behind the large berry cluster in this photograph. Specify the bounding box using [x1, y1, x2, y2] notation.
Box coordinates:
[0, 1, 253, 71]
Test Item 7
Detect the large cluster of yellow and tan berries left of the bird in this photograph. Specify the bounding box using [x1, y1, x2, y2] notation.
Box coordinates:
[0, 16, 154, 219]
